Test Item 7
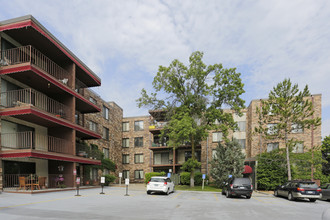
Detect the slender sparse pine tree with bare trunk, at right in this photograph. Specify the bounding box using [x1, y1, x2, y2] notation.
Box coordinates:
[255, 79, 321, 180]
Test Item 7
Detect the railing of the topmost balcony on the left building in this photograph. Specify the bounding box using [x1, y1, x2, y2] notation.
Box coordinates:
[0, 45, 70, 85]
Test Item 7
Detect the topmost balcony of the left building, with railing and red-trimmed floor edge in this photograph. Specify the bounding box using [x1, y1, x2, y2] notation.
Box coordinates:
[0, 45, 101, 113]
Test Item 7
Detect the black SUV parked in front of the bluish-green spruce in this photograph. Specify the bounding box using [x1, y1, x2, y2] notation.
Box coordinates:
[222, 177, 253, 199]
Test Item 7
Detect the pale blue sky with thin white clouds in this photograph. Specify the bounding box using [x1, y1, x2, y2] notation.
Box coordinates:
[0, 0, 330, 138]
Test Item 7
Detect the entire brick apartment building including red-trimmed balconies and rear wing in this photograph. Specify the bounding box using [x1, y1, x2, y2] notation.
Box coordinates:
[0, 16, 321, 189]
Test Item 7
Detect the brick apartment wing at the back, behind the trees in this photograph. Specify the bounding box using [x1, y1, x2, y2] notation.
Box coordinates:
[119, 95, 321, 181]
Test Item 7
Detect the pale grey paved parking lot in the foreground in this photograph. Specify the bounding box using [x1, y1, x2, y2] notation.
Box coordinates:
[0, 187, 330, 220]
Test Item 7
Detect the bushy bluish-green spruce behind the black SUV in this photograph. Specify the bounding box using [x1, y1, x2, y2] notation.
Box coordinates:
[210, 140, 245, 187]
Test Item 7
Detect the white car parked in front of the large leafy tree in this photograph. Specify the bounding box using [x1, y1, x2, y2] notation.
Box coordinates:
[147, 176, 174, 195]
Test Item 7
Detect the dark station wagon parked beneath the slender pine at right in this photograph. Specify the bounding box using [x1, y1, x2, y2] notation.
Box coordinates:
[274, 180, 322, 202]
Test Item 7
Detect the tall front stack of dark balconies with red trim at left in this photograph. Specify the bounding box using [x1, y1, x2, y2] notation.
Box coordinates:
[0, 15, 102, 189]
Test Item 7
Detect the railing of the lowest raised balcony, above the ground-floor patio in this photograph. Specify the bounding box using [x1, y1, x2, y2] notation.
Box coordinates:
[1, 131, 73, 154]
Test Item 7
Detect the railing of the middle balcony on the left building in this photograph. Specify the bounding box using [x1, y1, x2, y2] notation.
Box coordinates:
[0, 88, 70, 119]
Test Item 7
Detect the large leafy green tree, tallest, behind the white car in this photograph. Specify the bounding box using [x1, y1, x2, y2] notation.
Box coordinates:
[137, 51, 244, 186]
